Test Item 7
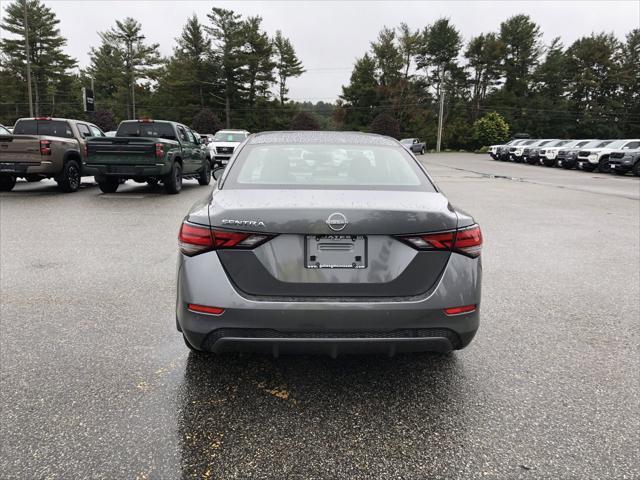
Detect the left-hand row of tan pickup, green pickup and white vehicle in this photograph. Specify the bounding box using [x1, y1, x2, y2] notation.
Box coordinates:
[0, 117, 249, 193]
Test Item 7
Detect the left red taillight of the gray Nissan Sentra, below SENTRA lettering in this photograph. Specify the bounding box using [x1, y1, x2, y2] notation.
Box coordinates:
[178, 222, 273, 257]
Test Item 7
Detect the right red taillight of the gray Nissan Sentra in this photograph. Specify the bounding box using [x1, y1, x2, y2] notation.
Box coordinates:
[398, 225, 482, 258]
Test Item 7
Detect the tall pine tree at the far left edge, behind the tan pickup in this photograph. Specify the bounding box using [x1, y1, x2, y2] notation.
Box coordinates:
[0, 0, 76, 116]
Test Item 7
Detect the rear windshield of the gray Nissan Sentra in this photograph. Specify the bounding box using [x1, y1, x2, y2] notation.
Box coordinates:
[225, 145, 435, 191]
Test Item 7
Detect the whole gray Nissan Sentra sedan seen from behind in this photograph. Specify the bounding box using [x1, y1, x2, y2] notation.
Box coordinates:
[176, 132, 482, 357]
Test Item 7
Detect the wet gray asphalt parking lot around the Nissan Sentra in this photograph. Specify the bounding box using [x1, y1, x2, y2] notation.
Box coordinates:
[0, 154, 640, 479]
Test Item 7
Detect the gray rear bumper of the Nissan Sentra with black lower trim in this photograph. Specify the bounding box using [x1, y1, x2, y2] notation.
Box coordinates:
[176, 252, 482, 355]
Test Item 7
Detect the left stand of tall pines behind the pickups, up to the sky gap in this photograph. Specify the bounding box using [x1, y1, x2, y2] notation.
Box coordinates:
[0, 0, 304, 133]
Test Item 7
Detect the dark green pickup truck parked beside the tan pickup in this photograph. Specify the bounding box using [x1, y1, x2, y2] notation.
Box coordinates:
[87, 119, 211, 193]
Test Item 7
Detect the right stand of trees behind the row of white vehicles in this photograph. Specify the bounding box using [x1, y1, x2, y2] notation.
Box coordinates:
[334, 15, 640, 148]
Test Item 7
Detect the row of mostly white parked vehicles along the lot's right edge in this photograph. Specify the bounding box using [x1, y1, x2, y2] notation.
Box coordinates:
[488, 138, 640, 176]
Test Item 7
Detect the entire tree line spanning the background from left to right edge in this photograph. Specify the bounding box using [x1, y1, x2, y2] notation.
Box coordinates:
[0, 0, 640, 148]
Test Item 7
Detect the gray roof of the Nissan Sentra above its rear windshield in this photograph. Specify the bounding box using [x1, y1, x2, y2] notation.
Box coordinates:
[247, 130, 398, 146]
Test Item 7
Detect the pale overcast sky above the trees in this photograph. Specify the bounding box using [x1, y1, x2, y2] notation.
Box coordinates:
[0, 0, 640, 101]
